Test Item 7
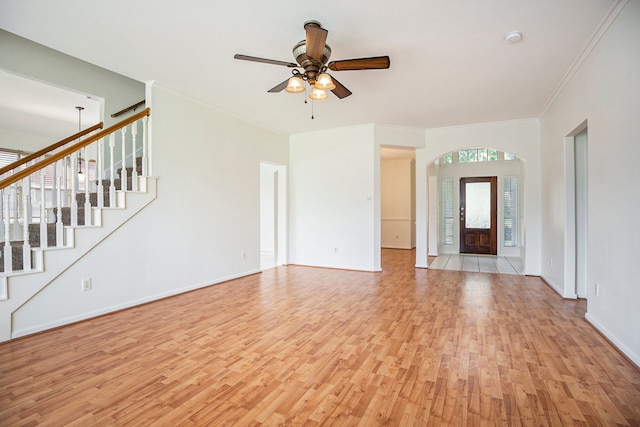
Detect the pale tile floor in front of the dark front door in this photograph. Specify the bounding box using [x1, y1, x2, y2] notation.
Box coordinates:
[429, 254, 524, 274]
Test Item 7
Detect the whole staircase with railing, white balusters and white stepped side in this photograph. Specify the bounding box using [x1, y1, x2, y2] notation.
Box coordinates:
[0, 109, 156, 342]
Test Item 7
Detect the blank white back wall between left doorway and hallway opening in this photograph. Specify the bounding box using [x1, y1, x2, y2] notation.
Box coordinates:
[289, 126, 380, 271]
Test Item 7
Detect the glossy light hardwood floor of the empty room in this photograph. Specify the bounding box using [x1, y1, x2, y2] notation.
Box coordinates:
[0, 250, 640, 426]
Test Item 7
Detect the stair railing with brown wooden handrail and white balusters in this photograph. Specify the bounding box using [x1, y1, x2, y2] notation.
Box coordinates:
[0, 108, 151, 276]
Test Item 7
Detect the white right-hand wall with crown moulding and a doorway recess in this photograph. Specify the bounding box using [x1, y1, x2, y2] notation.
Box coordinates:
[541, 1, 640, 365]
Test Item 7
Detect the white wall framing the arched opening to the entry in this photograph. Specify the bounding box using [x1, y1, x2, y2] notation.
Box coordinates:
[416, 119, 541, 275]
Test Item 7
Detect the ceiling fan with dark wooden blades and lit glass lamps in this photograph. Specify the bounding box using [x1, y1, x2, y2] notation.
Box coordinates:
[234, 21, 390, 100]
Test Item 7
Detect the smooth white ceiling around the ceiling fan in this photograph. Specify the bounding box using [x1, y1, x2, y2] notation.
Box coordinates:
[0, 0, 617, 133]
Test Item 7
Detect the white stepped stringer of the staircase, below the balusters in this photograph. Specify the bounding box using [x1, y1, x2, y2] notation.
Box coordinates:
[0, 177, 157, 342]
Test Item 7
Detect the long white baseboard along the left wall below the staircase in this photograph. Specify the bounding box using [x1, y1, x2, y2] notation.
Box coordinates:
[11, 270, 261, 339]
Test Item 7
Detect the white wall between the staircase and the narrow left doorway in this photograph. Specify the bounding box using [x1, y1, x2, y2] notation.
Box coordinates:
[11, 87, 288, 336]
